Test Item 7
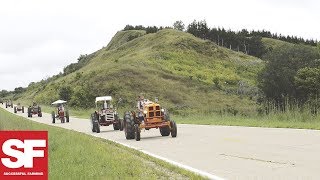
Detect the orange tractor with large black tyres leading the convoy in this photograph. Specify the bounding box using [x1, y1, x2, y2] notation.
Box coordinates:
[123, 97, 177, 141]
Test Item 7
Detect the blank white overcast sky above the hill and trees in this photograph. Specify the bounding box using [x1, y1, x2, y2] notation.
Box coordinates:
[0, 0, 320, 90]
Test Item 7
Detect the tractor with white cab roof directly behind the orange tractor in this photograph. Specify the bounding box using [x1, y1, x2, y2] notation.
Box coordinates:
[91, 96, 123, 133]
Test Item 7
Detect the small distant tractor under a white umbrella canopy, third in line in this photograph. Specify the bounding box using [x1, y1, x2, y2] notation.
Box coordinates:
[51, 100, 69, 123]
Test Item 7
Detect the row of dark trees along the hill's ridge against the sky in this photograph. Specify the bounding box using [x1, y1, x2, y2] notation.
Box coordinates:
[123, 20, 318, 58]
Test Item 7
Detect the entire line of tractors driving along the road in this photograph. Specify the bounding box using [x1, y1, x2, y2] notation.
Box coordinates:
[0, 96, 177, 141]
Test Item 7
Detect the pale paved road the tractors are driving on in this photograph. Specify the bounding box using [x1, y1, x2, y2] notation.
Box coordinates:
[1, 106, 320, 180]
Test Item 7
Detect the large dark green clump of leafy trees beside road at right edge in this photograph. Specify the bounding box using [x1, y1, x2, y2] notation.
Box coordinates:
[258, 44, 320, 114]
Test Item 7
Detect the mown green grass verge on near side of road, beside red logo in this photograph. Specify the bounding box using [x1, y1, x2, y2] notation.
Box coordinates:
[0, 108, 203, 179]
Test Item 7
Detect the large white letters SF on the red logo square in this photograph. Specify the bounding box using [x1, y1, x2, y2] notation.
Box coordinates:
[1, 139, 46, 169]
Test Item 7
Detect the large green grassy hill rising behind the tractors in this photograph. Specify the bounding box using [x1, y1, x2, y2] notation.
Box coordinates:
[18, 29, 263, 114]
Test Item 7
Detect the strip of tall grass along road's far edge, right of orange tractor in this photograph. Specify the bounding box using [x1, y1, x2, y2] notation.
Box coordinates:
[171, 112, 320, 130]
